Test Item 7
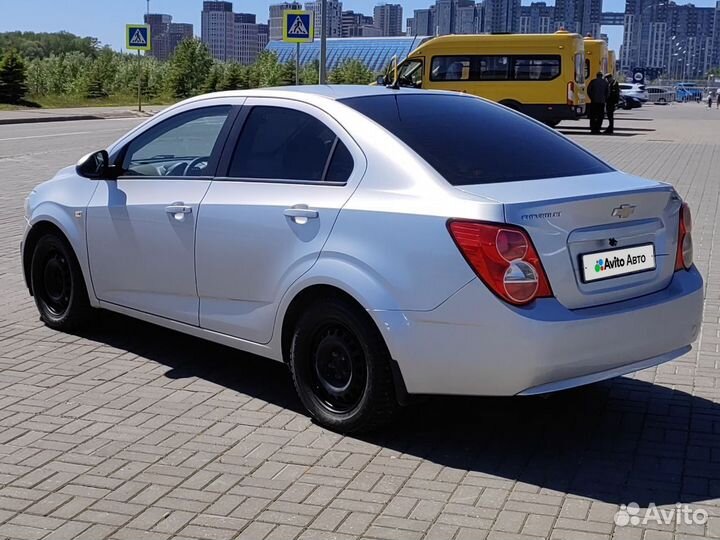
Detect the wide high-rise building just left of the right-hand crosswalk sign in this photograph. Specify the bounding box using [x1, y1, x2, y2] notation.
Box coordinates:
[202, 2, 269, 64]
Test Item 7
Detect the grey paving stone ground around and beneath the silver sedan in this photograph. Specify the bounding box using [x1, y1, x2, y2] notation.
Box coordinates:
[0, 104, 720, 540]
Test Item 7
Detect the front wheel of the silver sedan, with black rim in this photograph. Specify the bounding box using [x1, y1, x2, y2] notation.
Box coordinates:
[30, 233, 92, 332]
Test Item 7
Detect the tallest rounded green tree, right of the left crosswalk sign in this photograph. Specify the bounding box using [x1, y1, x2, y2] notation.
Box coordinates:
[168, 38, 213, 98]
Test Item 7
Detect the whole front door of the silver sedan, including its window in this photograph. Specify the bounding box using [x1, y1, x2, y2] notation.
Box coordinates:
[86, 101, 237, 326]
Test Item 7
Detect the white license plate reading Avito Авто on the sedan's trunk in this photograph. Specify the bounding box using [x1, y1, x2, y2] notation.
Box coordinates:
[581, 244, 655, 282]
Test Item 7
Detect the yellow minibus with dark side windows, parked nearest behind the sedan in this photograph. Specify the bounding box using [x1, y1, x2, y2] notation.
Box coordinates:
[378, 30, 585, 126]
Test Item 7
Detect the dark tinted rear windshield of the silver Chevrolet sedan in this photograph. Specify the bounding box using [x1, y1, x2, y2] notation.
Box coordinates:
[341, 90, 612, 186]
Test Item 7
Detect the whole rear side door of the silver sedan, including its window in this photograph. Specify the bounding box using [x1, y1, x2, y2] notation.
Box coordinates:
[196, 99, 365, 343]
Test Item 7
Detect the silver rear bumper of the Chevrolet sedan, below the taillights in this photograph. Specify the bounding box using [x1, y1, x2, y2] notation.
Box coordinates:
[371, 267, 703, 396]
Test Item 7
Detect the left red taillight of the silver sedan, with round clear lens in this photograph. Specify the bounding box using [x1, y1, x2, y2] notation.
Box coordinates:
[448, 221, 552, 305]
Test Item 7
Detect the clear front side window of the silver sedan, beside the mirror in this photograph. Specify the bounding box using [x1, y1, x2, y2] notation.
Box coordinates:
[122, 105, 231, 176]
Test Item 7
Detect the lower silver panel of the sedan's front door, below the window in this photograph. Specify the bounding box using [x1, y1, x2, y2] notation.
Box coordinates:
[87, 178, 210, 325]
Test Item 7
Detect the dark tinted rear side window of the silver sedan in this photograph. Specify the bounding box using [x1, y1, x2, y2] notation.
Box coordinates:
[228, 106, 353, 182]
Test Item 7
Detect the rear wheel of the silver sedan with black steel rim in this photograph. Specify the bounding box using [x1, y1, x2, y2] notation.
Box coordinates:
[289, 297, 398, 433]
